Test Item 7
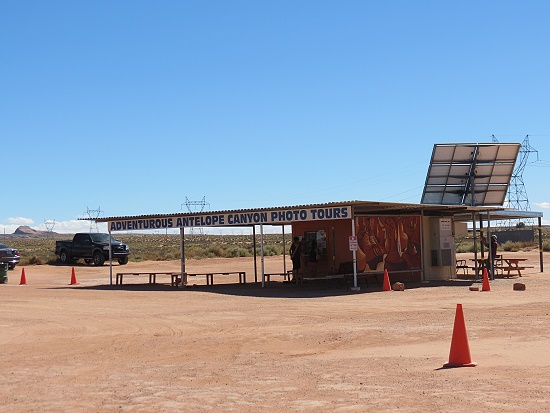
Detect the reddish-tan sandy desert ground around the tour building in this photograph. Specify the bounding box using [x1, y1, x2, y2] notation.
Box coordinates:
[0, 251, 550, 413]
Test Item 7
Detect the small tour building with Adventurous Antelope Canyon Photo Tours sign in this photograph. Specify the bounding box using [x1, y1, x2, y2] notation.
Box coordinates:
[95, 201, 542, 287]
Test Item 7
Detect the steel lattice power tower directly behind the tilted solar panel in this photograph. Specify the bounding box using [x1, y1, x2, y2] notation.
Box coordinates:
[492, 135, 538, 229]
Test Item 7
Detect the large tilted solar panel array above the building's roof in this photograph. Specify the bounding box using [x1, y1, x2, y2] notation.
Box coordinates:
[421, 143, 521, 206]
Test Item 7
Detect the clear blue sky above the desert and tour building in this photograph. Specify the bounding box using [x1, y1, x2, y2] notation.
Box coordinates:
[0, 0, 550, 233]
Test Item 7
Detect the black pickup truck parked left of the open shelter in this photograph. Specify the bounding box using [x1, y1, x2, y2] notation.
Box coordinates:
[55, 233, 130, 265]
